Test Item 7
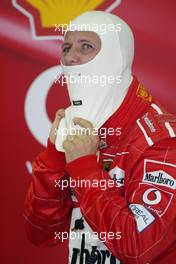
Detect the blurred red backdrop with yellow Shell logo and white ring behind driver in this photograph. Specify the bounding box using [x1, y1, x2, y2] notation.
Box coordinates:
[0, 0, 176, 264]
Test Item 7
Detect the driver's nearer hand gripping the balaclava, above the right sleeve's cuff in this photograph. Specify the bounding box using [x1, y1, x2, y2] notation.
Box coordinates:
[63, 117, 99, 163]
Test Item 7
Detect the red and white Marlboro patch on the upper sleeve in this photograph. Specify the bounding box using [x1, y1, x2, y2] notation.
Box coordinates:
[142, 160, 176, 190]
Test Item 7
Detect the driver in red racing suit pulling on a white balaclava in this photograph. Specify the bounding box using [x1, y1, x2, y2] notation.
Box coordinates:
[24, 11, 176, 264]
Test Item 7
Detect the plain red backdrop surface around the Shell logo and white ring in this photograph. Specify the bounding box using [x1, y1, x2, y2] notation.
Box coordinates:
[0, 0, 176, 264]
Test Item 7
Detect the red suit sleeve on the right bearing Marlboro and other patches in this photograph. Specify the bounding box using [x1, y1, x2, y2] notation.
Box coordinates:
[66, 141, 176, 264]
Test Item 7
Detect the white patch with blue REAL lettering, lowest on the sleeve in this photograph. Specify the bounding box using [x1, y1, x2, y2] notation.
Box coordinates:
[129, 204, 155, 232]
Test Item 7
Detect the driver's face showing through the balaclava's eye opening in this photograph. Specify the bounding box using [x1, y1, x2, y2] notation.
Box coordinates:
[61, 31, 101, 66]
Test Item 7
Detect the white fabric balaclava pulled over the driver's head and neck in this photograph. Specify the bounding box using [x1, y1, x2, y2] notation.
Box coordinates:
[56, 11, 134, 152]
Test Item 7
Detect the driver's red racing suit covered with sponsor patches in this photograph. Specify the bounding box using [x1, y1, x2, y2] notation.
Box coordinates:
[24, 77, 176, 264]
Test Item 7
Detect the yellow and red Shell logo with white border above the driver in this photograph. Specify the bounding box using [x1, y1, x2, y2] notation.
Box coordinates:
[12, 0, 121, 40]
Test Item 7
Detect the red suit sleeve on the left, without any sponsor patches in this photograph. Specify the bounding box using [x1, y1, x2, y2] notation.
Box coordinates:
[24, 139, 72, 246]
